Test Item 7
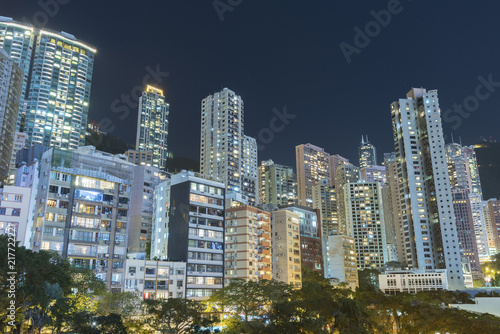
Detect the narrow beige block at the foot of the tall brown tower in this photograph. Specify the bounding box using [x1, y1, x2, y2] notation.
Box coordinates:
[313, 180, 339, 236]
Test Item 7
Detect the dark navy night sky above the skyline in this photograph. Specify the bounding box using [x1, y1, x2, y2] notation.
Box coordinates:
[0, 0, 500, 167]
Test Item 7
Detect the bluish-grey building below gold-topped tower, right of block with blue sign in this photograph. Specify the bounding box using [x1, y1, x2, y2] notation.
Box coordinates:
[127, 165, 168, 253]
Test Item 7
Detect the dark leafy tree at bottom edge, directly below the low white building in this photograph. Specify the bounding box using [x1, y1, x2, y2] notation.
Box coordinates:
[144, 298, 205, 333]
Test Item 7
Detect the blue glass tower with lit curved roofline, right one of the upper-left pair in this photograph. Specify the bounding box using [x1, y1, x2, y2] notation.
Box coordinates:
[24, 30, 96, 150]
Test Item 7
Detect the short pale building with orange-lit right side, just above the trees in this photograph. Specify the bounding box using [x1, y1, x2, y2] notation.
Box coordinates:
[324, 234, 359, 290]
